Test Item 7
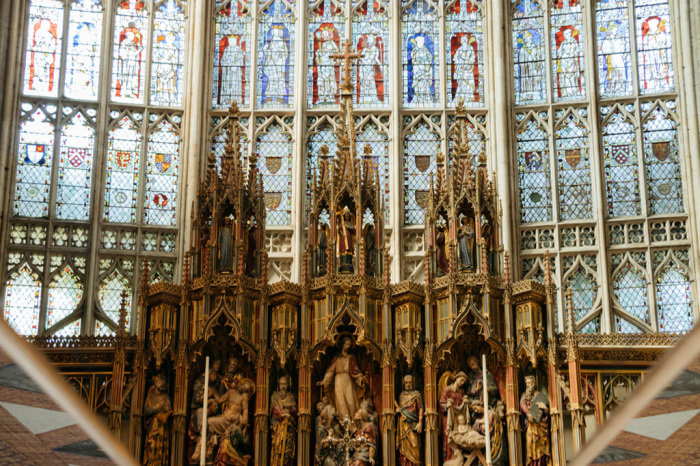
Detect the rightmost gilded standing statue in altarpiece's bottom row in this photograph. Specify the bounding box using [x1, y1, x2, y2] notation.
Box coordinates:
[520, 376, 552, 466]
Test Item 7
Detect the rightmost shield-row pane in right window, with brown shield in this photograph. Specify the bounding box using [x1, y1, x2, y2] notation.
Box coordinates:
[642, 105, 683, 215]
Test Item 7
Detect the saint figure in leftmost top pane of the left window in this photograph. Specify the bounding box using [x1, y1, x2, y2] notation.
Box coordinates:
[29, 19, 58, 92]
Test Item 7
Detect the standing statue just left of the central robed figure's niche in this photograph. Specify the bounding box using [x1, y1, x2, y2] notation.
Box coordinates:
[270, 375, 297, 466]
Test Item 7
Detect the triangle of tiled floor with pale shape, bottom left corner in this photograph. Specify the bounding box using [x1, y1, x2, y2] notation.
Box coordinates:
[0, 352, 114, 466]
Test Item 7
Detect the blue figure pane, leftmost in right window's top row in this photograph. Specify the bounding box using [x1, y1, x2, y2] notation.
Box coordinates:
[513, 0, 547, 105]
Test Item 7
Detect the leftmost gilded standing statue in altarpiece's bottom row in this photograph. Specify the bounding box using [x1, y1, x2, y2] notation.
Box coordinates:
[143, 374, 173, 466]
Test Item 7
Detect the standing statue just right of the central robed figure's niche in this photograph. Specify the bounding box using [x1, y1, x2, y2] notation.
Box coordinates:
[396, 375, 423, 466]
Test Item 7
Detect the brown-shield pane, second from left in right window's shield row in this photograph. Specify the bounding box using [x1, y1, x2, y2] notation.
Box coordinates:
[555, 115, 593, 220]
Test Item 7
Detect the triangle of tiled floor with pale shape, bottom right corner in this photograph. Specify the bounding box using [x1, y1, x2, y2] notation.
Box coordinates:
[596, 358, 700, 466]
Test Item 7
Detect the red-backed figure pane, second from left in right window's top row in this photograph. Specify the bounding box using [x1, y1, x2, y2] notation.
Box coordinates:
[550, 0, 586, 102]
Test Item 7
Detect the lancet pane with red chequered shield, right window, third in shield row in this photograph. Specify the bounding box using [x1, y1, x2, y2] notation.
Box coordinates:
[601, 107, 641, 218]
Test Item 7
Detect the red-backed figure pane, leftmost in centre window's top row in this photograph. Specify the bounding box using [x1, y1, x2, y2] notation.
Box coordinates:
[212, 0, 253, 108]
